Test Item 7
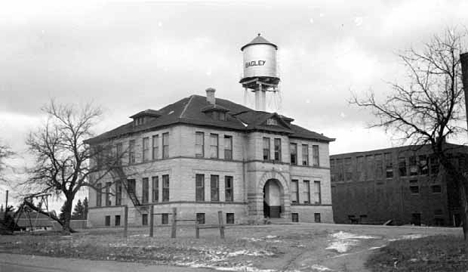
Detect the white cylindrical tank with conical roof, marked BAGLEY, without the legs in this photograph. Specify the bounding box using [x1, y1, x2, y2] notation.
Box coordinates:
[240, 34, 280, 89]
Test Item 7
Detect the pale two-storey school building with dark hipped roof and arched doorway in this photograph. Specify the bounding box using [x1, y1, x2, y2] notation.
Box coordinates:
[87, 89, 334, 226]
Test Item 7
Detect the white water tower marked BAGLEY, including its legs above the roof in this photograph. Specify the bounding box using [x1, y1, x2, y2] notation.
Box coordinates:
[239, 33, 280, 111]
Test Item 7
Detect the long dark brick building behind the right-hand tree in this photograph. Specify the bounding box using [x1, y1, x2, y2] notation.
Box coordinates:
[330, 144, 468, 226]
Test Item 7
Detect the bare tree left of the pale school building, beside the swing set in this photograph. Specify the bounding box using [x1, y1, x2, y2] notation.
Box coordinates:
[21, 100, 120, 233]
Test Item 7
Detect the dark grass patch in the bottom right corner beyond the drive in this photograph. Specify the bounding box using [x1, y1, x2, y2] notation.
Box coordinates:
[366, 235, 468, 272]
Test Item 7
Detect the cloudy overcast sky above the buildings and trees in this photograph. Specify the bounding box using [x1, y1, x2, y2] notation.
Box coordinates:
[0, 0, 468, 206]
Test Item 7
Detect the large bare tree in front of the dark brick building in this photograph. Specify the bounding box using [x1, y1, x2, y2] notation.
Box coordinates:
[351, 30, 468, 240]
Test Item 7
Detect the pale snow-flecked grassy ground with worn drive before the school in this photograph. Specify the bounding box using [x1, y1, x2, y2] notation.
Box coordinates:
[0, 223, 468, 272]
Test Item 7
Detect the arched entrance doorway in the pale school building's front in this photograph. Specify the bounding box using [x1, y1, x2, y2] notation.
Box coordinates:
[263, 179, 284, 218]
